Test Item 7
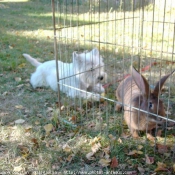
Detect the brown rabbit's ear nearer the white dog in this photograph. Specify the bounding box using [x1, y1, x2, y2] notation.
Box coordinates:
[130, 66, 150, 98]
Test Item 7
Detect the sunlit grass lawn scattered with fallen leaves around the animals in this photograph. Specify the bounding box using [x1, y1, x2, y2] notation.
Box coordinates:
[0, 0, 175, 174]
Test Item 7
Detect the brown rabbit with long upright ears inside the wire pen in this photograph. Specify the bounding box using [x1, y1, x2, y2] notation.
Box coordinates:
[116, 67, 174, 137]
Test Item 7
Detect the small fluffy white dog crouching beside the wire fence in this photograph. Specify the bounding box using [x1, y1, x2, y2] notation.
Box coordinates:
[23, 48, 107, 100]
